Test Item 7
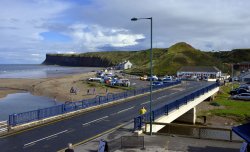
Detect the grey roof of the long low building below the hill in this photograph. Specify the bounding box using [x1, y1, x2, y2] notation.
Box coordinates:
[178, 66, 220, 72]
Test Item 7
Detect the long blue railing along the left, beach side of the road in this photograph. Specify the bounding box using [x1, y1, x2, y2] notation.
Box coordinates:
[8, 81, 181, 126]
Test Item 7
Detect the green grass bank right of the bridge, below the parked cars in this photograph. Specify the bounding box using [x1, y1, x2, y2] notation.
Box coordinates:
[209, 84, 250, 122]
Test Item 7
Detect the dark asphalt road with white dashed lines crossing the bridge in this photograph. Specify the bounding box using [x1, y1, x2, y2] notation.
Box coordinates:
[0, 82, 213, 152]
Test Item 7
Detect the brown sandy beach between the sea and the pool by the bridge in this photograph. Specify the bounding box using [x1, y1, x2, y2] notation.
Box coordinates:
[0, 72, 124, 102]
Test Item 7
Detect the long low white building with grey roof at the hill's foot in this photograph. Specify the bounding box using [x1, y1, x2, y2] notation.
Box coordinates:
[177, 66, 221, 79]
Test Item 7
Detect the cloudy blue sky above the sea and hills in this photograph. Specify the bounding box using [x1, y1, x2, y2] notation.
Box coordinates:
[0, 0, 250, 64]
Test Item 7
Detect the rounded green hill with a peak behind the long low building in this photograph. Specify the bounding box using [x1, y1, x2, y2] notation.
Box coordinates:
[127, 42, 222, 75]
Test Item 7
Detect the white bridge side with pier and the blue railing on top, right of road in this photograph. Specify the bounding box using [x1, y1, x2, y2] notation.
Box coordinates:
[134, 83, 219, 132]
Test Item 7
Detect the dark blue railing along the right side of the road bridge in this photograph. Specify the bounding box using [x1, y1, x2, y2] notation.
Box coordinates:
[134, 83, 219, 130]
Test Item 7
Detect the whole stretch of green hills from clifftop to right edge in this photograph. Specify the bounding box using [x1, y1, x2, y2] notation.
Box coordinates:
[44, 42, 250, 76]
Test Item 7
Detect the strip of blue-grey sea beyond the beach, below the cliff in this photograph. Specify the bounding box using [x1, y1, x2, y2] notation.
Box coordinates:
[0, 64, 100, 78]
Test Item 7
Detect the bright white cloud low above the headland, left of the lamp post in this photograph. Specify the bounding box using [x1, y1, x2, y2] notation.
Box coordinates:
[68, 24, 145, 51]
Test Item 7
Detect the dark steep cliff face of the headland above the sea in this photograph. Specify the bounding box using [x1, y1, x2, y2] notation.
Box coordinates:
[43, 54, 113, 67]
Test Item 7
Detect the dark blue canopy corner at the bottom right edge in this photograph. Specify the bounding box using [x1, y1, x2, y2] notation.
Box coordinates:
[232, 123, 250, 143]
